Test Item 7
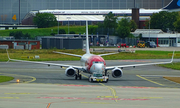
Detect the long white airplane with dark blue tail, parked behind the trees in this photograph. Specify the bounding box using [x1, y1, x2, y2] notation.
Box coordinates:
[31, 0, 180, 18]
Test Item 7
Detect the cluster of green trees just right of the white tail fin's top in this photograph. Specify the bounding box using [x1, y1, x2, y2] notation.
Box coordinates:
[89, 12, 137, 38]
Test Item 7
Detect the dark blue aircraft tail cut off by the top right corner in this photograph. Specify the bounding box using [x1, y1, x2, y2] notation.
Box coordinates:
[163, 0, 180, 10]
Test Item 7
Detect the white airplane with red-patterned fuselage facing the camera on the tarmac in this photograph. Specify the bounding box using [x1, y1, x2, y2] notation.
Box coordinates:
[6, 21, 174, 80]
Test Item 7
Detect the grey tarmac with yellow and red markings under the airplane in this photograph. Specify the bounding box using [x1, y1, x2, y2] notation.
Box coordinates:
[0, 59, 180, 108]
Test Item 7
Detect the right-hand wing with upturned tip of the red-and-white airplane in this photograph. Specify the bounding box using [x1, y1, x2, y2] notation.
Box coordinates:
[106, 52, 174, 70]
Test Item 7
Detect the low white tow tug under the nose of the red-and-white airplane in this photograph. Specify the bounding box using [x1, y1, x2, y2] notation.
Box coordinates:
[89, 72, 109, 82]
